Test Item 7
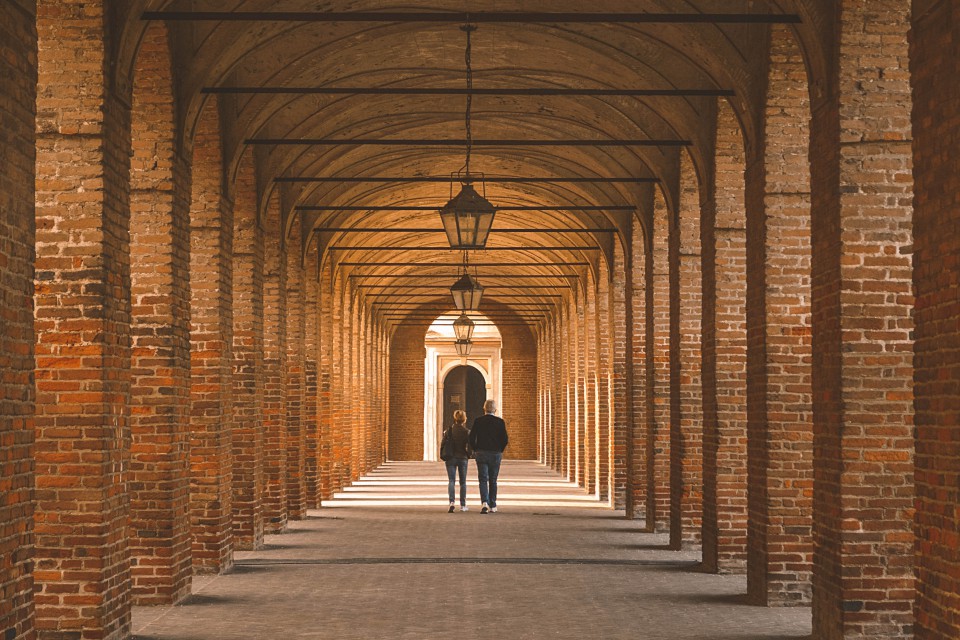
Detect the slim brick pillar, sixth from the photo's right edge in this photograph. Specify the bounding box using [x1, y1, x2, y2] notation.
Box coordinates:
[646, 191, 670, 532]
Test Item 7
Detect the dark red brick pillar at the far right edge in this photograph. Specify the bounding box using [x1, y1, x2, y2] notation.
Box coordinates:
[910, 2, 960, 640]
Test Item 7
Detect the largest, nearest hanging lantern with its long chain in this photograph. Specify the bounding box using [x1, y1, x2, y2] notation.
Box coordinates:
[440, 24, 497, 249]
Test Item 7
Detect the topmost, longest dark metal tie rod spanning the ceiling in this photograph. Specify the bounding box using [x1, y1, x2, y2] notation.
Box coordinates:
[141, 11, 801, 24]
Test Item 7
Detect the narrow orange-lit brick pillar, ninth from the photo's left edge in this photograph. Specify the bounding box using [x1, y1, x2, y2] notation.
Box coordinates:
[317, 260, 336, 499]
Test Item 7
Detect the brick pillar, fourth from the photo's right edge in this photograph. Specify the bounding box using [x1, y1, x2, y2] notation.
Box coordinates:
[700, 101, 747, 573]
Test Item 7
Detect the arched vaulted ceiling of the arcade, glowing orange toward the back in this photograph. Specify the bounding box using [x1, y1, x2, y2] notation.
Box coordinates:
[114, 0, 832, 332]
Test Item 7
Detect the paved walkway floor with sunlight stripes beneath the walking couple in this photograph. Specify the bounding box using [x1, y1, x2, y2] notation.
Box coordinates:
[133, 462, 810, 640]
